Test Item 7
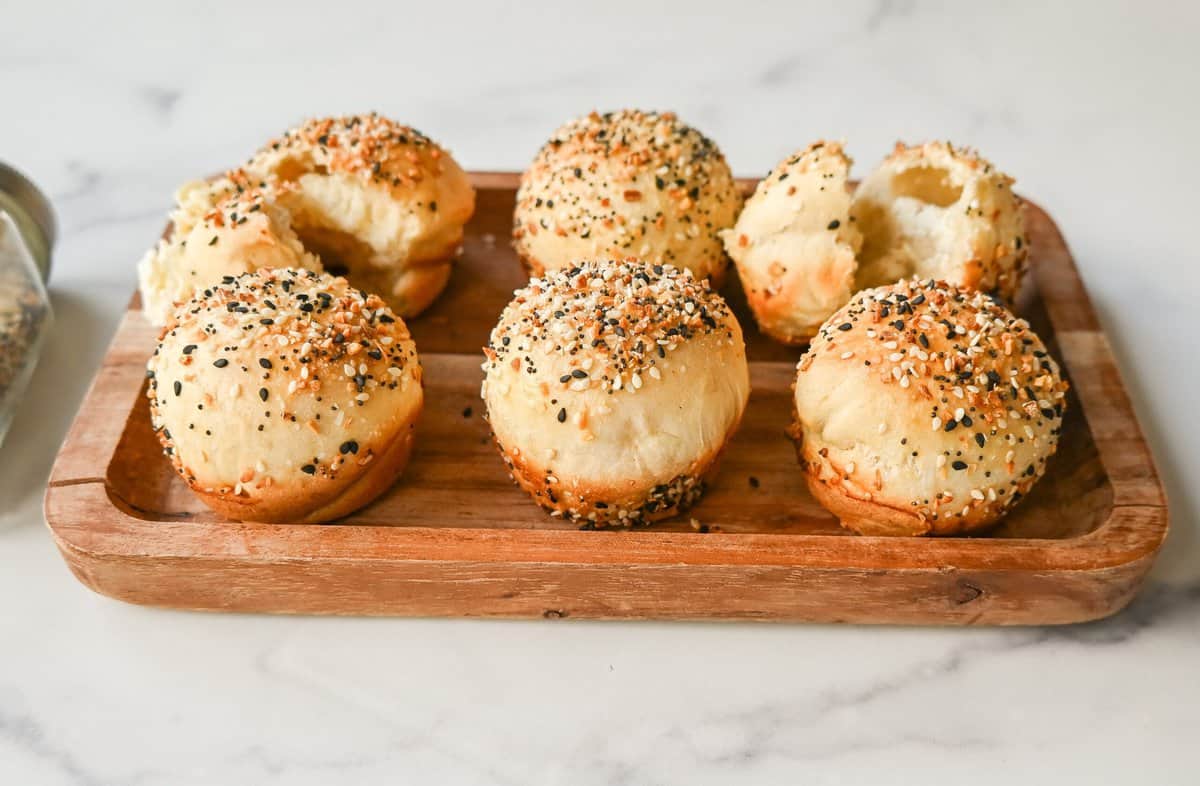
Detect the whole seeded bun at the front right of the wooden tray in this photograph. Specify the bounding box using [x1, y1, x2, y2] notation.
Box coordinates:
[791, 280, 1067, 534]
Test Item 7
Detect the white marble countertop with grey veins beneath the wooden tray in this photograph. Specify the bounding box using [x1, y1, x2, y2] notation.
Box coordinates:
[0, 0, 1200, 785]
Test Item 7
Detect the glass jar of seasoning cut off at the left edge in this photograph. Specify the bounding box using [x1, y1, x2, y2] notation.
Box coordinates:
[0, 162, 54, 442]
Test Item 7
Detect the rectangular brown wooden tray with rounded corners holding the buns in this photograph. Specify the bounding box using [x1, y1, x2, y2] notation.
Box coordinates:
[46, 174, 1166, 624]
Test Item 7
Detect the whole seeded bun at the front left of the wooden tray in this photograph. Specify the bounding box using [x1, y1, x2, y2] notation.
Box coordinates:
[148, 269, 422, 522]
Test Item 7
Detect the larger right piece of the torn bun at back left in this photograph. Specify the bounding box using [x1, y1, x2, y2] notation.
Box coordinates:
[246, 113, 475, 317]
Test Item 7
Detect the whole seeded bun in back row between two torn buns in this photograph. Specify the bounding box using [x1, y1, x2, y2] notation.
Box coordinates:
[512, 110, 742, 283]
